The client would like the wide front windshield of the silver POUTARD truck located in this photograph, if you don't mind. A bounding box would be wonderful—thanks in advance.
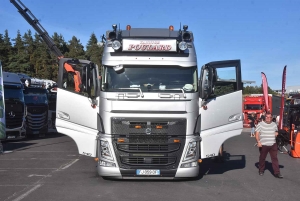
[102,65,198,93]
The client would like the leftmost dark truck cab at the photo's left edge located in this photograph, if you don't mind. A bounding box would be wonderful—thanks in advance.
[3,72,26,140]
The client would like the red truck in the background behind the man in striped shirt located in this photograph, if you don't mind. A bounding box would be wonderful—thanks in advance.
[243,94,281,128]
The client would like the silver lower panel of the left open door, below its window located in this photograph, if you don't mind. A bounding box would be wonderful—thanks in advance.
[56,88,99,157]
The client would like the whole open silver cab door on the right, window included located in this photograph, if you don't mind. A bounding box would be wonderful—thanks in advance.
[199,60,243,159]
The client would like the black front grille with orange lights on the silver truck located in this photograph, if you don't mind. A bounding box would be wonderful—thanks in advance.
[111,118,186,169]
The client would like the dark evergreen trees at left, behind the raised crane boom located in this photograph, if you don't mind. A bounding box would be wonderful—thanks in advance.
[0,30,103,81]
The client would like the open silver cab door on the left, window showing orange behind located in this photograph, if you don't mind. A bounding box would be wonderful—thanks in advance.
[56,58,100,157]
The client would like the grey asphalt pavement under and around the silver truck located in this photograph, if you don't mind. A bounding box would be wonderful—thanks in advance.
[0,129,300,201]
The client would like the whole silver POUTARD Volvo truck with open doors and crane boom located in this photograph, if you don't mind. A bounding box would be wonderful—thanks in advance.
[11,0,243,179]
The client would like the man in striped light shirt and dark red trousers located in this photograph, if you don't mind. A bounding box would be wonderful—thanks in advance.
[255,113,283,178]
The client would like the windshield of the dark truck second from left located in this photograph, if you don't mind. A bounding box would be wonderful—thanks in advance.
[24,88,48,104]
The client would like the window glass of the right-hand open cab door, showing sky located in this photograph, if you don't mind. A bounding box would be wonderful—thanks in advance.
[214,67,237,96]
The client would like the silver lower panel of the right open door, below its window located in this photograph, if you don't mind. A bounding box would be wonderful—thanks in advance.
[200,91,243,158]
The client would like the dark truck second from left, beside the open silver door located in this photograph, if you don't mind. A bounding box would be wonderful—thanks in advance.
[19,74,48,136]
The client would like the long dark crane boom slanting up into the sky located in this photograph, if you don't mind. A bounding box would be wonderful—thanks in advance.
[10,0,64,59]
